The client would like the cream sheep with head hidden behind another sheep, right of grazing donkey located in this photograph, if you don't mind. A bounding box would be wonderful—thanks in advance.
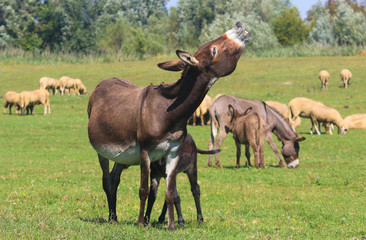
[288,97,324,133]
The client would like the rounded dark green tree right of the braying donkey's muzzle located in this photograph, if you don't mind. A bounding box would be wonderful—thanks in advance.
[273,7,309,45]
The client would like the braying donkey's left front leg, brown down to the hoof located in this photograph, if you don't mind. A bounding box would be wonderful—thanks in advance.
[138,148,150,226]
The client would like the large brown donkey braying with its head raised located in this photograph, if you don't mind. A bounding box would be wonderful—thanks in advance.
[88,22,250,229]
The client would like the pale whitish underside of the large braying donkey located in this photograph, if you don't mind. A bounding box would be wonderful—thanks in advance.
[93,140,179,165]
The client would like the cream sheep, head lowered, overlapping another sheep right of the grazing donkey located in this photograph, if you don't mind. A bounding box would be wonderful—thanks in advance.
[310,106,348,135]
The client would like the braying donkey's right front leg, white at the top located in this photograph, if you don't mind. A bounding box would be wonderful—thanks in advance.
[165,151,179,230]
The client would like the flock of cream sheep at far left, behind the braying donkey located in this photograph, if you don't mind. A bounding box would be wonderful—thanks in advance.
[4,76,87,115]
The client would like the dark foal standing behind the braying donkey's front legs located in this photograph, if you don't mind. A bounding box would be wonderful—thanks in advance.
[145,134,220,227]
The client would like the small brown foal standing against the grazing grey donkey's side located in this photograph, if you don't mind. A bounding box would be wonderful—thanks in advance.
[229,105,265,168]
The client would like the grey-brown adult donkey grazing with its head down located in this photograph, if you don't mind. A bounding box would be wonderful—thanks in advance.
[208,95,305,168]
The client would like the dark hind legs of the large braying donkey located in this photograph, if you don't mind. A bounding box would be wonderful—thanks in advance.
[98,154,127,222]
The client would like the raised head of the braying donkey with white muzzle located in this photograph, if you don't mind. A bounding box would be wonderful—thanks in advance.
[158,22,250,78]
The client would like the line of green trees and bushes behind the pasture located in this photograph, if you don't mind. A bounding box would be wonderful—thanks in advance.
[0,0,366,60]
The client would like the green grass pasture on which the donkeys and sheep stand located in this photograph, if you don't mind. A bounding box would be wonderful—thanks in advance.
[0,54,366,239]
